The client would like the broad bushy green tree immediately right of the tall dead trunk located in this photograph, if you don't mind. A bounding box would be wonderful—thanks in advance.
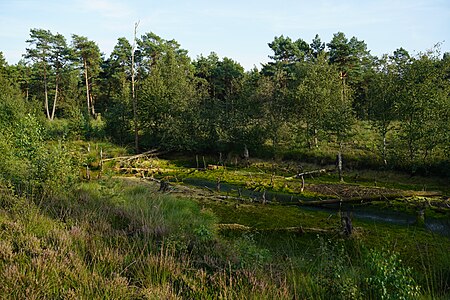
[138,34,197,150]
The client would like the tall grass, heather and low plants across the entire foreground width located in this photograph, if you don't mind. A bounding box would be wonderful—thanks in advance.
[0,179,449,299]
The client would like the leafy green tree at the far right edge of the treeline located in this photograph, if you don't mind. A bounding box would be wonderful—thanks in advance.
[398,49,449,172]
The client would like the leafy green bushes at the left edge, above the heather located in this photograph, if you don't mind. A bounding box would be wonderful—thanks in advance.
[0,76,76,196]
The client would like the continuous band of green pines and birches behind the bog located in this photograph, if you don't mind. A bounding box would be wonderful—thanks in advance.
[0,29,450,170]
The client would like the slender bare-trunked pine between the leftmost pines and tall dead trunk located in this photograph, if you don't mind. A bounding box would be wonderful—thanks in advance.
[72,34,102,117]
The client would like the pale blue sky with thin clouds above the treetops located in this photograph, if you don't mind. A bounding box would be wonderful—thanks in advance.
[0,0,450,70]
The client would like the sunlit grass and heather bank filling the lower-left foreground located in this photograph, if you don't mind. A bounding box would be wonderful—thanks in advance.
[0,179,300,299]
